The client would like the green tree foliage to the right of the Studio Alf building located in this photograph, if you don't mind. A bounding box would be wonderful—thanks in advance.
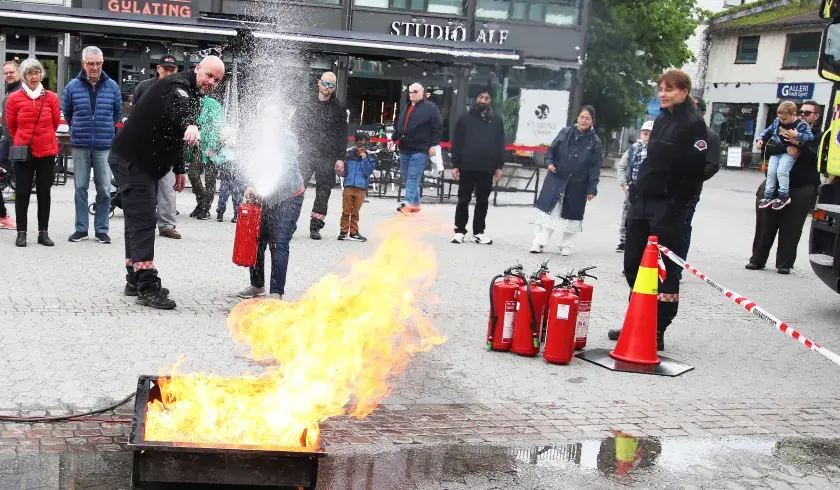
[583,0,705,138]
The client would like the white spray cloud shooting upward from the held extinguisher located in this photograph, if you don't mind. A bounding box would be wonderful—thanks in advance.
[225,0,315,196]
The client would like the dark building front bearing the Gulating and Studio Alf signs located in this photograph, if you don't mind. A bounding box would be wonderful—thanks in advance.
[0,0,589,145]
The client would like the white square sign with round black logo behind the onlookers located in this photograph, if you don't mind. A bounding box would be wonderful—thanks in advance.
[516,89,569,146]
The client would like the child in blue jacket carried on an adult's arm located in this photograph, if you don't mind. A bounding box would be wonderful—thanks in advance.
[756,101,814,211]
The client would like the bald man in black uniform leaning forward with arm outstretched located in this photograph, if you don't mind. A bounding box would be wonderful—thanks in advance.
[108,56,225,310]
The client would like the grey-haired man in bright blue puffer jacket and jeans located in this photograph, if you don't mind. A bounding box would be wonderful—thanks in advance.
[61,46,122,243]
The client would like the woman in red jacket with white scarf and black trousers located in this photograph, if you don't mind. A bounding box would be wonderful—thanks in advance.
[5,58,61,247]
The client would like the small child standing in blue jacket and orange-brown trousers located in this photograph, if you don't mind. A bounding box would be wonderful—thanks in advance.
[338,132,376,242]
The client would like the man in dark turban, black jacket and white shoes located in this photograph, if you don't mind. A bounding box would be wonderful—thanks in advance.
[451,87,505,245]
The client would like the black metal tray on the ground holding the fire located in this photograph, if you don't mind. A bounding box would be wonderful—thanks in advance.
[128,376,327,490]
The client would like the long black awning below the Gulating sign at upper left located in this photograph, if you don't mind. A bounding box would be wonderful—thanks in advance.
[0,2,236,41]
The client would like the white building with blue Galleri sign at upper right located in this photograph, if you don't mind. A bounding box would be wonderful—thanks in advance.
[704,2,831,164]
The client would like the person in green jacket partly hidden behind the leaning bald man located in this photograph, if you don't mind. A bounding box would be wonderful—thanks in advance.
[187,95,224,220]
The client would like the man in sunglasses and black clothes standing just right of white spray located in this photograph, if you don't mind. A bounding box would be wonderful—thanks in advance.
[299,71,347,240]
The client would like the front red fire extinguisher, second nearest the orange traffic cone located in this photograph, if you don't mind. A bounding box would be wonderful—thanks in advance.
[543,276,580,364]
